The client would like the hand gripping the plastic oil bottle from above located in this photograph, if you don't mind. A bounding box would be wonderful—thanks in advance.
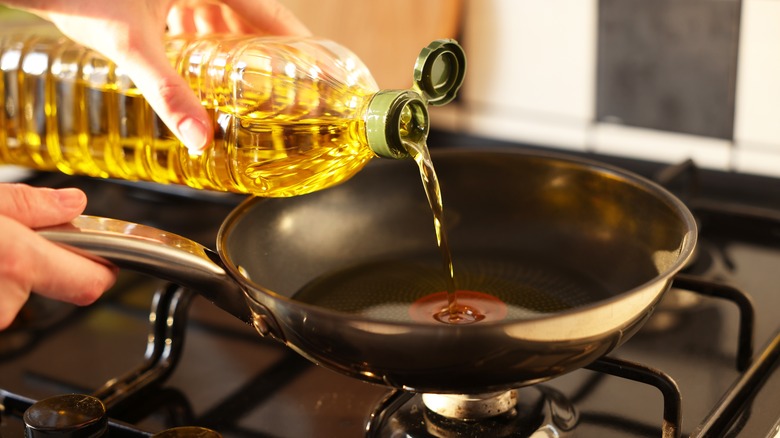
[0,0,309,151]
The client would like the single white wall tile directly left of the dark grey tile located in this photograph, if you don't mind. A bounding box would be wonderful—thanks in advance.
[462,0,596,128]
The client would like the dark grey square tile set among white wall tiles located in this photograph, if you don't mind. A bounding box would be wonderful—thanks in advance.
[596,0,740,139]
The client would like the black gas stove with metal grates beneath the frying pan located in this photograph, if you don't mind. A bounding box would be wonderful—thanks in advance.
[0,133,780,438]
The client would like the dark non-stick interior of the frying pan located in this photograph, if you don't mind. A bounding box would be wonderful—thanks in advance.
[224,151,691,322]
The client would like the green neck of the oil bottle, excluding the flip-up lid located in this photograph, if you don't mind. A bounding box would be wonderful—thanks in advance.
[365,90,430,159]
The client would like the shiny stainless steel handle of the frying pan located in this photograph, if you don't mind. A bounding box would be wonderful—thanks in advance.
[38,216,252,324]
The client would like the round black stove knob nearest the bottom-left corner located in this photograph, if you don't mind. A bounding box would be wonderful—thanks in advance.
[24,394,108,438]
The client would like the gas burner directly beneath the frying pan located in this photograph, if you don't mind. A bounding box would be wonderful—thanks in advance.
[368,385,579,438]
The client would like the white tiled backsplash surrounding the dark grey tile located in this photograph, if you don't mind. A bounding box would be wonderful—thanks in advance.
[444,0,780,177]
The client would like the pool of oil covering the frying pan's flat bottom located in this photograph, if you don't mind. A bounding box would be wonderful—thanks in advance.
[294,253,611,324]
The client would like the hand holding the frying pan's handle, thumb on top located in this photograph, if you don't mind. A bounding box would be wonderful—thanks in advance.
[0,184,116,330]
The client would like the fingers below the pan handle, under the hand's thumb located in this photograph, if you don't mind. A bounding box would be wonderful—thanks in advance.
[0,216,116,330]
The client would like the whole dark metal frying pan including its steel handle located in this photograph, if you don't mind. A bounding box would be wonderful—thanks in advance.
[41,149,696,394]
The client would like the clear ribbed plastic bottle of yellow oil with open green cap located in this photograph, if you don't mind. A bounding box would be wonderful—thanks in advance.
[0,34,465,197]
